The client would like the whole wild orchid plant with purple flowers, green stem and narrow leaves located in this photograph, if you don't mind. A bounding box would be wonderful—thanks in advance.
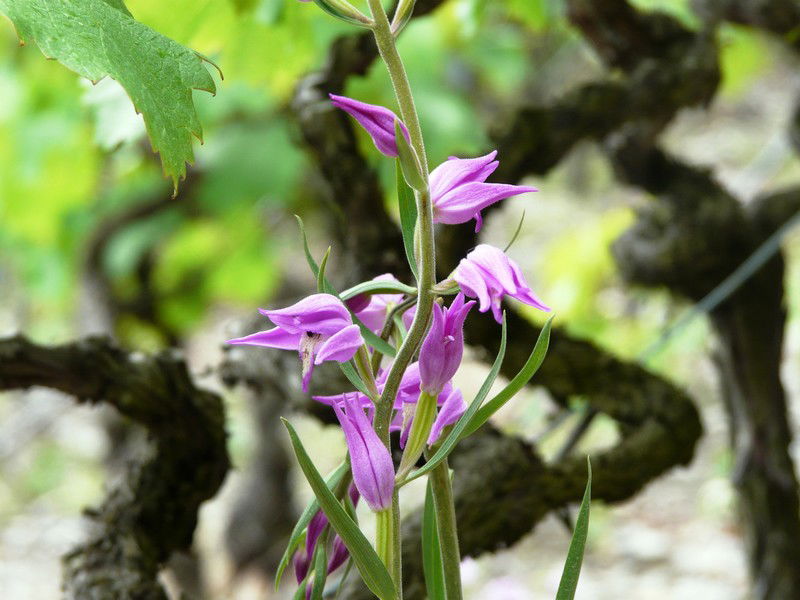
[230,0,589,600]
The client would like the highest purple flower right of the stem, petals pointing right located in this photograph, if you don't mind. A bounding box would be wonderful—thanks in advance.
[430,150,538,232]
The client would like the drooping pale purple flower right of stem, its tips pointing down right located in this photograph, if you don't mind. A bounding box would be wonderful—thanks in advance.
[453,244,550,323]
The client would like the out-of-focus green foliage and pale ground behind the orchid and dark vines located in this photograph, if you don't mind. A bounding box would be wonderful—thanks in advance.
[0,0,800,600]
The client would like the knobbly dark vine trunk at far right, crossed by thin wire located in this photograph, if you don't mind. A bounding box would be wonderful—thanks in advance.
[612,134,800,599]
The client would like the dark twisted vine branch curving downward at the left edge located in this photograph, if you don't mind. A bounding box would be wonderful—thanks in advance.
[0,337,229,600]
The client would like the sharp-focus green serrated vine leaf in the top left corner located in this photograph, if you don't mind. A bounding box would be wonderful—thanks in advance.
[0,0,216,190]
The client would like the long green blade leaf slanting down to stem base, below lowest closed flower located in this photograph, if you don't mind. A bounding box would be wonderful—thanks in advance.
[281,418,396,600]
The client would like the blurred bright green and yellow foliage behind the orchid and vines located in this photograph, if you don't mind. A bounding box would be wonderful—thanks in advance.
[0,0,792,356]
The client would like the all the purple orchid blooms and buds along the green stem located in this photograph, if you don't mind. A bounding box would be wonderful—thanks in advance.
[230,95,549,582]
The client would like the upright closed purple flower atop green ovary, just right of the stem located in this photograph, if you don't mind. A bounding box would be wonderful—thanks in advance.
[419,293,475,396]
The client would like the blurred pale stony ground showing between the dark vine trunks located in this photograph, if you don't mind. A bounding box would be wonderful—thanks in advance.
[0,27,800,600]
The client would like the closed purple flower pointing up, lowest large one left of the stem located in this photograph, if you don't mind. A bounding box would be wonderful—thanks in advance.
[333,394,394,512]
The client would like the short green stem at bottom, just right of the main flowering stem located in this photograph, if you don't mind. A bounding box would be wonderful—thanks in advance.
[429,459,462,600]
